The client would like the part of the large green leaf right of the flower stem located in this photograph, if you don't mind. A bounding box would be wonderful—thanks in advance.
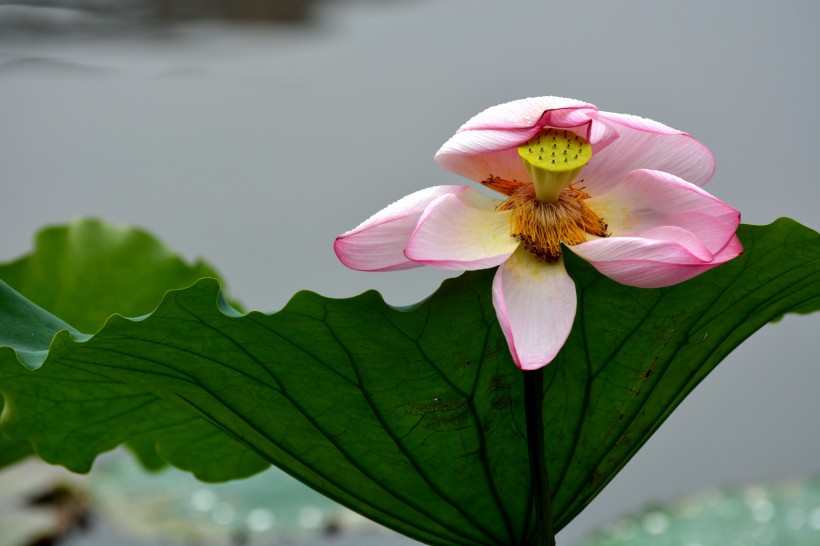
[544,218,820,528]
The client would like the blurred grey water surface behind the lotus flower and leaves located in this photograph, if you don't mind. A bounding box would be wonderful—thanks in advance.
[0,0,820,546]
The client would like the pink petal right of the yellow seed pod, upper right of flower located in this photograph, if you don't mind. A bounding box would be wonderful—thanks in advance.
[580,112,715,195]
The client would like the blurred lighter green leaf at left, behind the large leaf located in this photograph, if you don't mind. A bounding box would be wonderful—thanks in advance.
[0,219,231,468]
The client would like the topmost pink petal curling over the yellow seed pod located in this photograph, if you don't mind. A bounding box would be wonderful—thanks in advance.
[435,97,596,182]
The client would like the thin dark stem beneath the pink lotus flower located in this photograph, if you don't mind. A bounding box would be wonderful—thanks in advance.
[524,368,555,546]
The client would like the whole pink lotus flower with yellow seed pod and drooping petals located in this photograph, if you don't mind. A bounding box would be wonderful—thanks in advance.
[334,97,743,370]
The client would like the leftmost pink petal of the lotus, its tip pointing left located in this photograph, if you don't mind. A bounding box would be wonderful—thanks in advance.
[333,186,474,271]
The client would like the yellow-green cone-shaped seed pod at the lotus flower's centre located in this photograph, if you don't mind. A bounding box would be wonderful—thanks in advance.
[518,129,592,203]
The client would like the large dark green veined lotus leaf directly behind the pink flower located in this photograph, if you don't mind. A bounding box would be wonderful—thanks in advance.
[0,220,820,545]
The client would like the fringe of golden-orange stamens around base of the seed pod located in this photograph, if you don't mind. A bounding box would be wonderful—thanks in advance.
[498,184,607,263]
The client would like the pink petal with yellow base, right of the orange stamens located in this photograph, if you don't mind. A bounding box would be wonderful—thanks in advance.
[587,169,740,253]
